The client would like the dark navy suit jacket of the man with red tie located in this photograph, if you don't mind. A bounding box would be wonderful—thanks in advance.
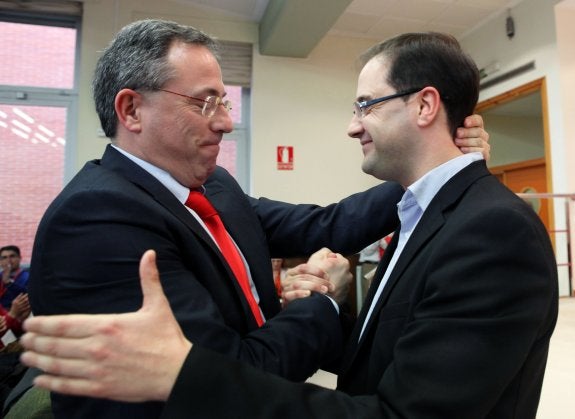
[30,147,401,419]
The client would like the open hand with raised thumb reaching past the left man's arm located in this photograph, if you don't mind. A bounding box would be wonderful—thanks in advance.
[21,250,192,402]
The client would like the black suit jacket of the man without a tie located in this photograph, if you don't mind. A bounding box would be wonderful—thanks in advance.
[169,161,558,419]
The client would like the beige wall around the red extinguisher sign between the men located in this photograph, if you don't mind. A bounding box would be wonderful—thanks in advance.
[252,37,376,203]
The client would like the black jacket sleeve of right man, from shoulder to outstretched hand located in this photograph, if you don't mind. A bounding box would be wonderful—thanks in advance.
[163,198,557,419]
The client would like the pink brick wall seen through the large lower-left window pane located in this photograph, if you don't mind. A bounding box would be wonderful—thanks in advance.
[0,105,65,262]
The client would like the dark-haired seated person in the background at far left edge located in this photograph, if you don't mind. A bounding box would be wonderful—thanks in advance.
[0,245,29,310]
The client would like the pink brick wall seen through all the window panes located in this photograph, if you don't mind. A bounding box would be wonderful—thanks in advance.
[0,22,242,263]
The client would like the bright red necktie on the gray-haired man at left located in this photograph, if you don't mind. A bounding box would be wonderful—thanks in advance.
[186,191,264,326]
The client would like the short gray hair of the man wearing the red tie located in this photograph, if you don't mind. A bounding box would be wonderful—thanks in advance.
[92,19,219,138]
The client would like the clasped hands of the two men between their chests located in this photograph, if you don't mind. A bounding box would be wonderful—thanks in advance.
[281,247,352,307]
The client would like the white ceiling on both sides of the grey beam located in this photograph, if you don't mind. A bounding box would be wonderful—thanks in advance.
[175,0,522,40]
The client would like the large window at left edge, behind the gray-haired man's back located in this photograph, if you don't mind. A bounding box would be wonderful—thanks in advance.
[0,13,78,263]
